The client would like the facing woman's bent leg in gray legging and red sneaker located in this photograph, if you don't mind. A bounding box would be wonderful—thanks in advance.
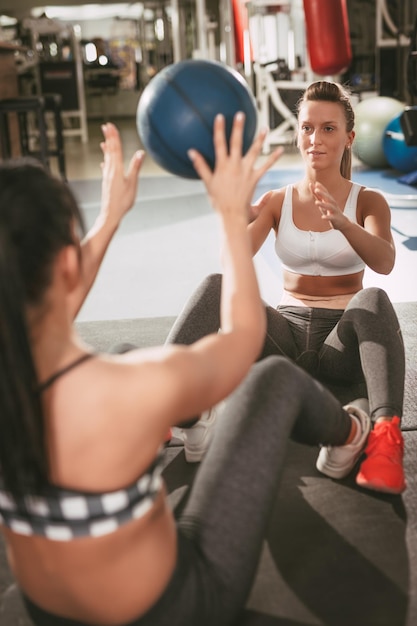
[321,288,406,493]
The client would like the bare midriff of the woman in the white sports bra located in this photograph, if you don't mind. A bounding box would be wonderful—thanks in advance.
[280,270,363,309]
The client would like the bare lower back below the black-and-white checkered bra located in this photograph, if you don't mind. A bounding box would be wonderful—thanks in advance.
[4,493,177,626]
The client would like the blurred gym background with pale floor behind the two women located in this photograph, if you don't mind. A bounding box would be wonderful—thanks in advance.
[0,0,417,320]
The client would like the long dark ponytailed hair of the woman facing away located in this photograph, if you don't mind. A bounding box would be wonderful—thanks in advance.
[0,159,84,494]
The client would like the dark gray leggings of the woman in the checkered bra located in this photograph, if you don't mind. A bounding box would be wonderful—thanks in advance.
[25,356,351,626]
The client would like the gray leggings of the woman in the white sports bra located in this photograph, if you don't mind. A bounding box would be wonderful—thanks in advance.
[167,274,405,419]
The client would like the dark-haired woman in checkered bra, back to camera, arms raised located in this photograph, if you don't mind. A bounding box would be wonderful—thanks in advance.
[0,114,367,626]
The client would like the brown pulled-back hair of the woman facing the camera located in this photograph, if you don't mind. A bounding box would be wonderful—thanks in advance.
[297,80,355,179]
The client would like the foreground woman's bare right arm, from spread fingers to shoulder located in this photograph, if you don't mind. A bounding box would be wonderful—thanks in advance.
[101,114,280,448]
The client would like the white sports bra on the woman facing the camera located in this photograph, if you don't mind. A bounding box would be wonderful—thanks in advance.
[275,183,365,276]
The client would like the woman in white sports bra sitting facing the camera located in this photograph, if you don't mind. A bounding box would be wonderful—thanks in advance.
[168,81,406,493]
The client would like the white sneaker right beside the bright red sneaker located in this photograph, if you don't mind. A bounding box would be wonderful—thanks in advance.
[316,398,371,478]
